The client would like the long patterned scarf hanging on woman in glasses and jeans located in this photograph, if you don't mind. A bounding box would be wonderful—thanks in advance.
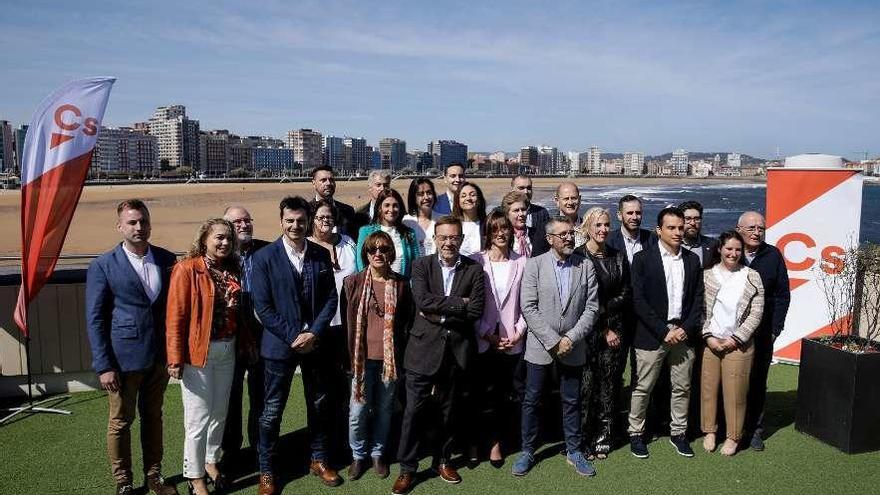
[352,274,397,404]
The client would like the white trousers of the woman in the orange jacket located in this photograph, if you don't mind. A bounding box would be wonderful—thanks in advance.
[180,339,235,478]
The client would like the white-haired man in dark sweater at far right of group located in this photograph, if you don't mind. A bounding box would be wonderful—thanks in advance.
[736,211,791,451]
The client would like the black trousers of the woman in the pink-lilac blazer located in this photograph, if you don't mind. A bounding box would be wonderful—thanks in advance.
[474,350,523,450]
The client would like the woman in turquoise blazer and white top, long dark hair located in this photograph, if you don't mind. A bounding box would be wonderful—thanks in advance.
[355,189,420,277]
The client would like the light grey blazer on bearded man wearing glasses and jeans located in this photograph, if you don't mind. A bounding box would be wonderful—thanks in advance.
[520,250,599,366]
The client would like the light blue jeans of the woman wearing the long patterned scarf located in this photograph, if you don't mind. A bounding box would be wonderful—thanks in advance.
[348,359,396,459]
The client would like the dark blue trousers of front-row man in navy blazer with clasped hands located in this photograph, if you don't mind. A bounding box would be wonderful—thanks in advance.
[259,351,332,473]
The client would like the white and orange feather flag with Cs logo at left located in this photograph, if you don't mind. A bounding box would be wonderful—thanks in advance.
[15,77,116,337]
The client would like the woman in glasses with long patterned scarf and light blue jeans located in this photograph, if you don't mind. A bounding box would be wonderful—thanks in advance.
[339,232,414,480]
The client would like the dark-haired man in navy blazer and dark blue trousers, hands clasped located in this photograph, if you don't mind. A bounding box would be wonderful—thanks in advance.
[251,196,342,495]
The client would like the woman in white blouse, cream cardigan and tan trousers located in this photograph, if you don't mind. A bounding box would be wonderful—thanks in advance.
[700,230,764,456]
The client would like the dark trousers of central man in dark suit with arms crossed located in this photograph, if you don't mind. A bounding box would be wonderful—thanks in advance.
[397,349,465,473]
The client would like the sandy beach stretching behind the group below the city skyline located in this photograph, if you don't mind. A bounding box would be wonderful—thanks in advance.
[0,177,760,260]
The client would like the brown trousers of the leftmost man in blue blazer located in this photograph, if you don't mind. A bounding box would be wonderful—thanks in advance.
[107,364,168,483]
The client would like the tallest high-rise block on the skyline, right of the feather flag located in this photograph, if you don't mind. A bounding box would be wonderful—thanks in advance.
[149,105,201,168]
